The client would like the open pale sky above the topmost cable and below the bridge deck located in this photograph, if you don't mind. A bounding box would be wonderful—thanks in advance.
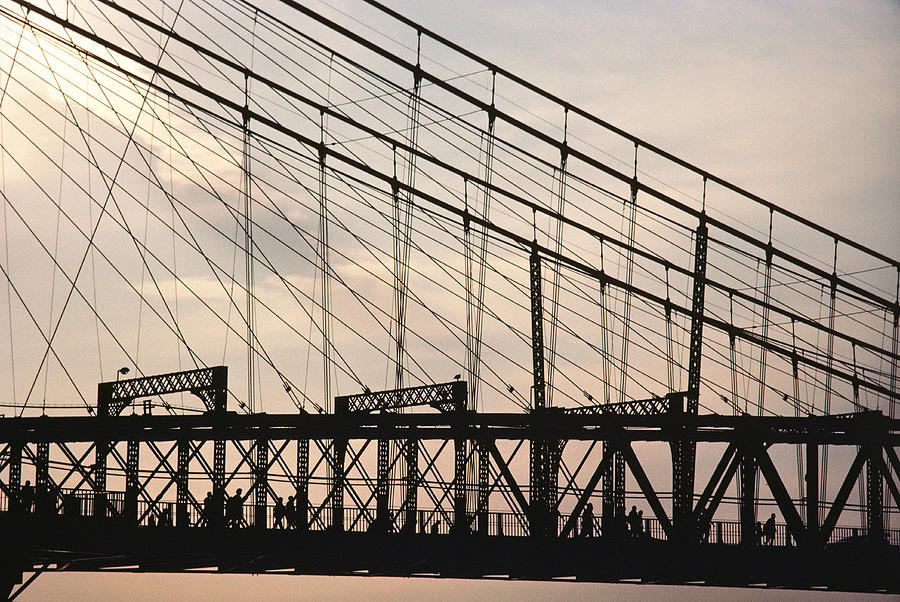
[12,0,900,600]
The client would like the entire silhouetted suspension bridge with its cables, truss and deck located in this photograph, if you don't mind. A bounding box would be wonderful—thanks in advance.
[0,0,900,597]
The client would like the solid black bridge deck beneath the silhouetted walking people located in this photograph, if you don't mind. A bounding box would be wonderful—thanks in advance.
[0,513,900,593]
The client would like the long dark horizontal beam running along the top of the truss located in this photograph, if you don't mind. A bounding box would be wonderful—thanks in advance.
[0,412,900,447]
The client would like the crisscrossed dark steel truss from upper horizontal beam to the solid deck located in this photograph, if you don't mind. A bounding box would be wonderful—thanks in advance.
[0,400,900,587]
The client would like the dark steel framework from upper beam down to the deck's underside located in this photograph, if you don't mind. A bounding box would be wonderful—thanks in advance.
[0,400,900,591]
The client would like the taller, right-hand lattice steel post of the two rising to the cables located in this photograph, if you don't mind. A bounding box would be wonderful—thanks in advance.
[672,212,709,538]
